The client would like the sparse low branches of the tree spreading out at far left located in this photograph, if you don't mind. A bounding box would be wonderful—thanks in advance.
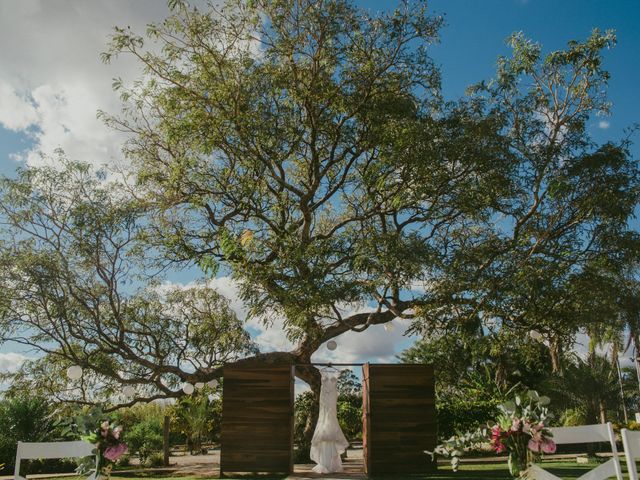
[0,156,257,403]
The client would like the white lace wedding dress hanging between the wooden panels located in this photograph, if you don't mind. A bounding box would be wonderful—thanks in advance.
[311,371,349,473]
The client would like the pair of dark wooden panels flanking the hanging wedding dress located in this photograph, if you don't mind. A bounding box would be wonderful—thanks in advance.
[220,363,437,478]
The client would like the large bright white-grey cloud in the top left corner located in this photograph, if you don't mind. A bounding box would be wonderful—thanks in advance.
[0,0,174,169]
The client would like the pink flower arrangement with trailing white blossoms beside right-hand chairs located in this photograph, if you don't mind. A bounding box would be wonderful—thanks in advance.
[425,390,556,477]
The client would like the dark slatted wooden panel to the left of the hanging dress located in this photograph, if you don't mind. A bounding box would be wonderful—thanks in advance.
[220,365,294,477]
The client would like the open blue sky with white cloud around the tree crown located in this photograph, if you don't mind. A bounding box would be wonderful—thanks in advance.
[0,0,640,368]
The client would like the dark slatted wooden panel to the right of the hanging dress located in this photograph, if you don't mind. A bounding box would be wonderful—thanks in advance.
[362,364,437,476]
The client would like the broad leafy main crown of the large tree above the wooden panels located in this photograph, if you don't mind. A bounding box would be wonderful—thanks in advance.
[1,0,638,450]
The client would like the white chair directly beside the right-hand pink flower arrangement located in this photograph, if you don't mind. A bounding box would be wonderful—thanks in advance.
[527,423,622,480]
